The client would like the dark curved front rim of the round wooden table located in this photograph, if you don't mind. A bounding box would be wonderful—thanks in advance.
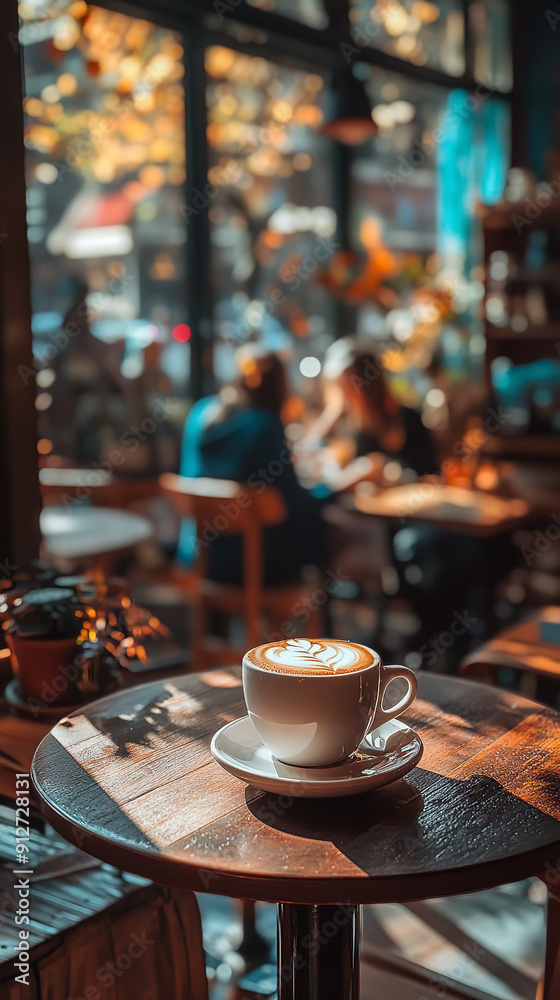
[31,760,560,905]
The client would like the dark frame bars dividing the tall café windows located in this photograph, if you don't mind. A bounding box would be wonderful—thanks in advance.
[95,0,520,400]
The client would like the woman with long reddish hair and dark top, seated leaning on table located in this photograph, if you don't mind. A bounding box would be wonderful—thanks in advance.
[304,338,511,658]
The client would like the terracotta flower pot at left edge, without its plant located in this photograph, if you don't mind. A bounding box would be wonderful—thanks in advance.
[6,632,78,707]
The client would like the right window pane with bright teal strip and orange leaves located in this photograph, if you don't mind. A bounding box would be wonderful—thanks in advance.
[345,67,509,405]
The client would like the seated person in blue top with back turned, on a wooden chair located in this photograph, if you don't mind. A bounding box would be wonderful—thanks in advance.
[177,345,325,586]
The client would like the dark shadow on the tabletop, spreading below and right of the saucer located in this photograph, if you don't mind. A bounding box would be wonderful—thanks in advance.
[247,767,560,877]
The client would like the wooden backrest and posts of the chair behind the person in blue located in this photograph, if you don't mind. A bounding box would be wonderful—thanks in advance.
[159,472,287,605]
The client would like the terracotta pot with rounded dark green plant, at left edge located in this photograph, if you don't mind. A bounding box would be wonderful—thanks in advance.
[6,587,82,707]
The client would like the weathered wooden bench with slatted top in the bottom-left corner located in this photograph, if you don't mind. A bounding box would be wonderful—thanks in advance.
[0,808,208,1000]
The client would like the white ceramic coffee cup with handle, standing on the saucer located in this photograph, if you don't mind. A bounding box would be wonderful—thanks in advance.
[243,639,418,767]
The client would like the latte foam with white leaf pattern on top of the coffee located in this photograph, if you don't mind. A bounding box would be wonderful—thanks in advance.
[247,639,376,674]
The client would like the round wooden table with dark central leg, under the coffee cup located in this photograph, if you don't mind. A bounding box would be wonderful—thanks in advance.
[32,668,560,1000]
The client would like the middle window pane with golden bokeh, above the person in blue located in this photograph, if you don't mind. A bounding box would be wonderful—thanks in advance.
[206,46,337,390]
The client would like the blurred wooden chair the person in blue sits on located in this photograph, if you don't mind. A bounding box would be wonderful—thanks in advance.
[160,473,321,670]
